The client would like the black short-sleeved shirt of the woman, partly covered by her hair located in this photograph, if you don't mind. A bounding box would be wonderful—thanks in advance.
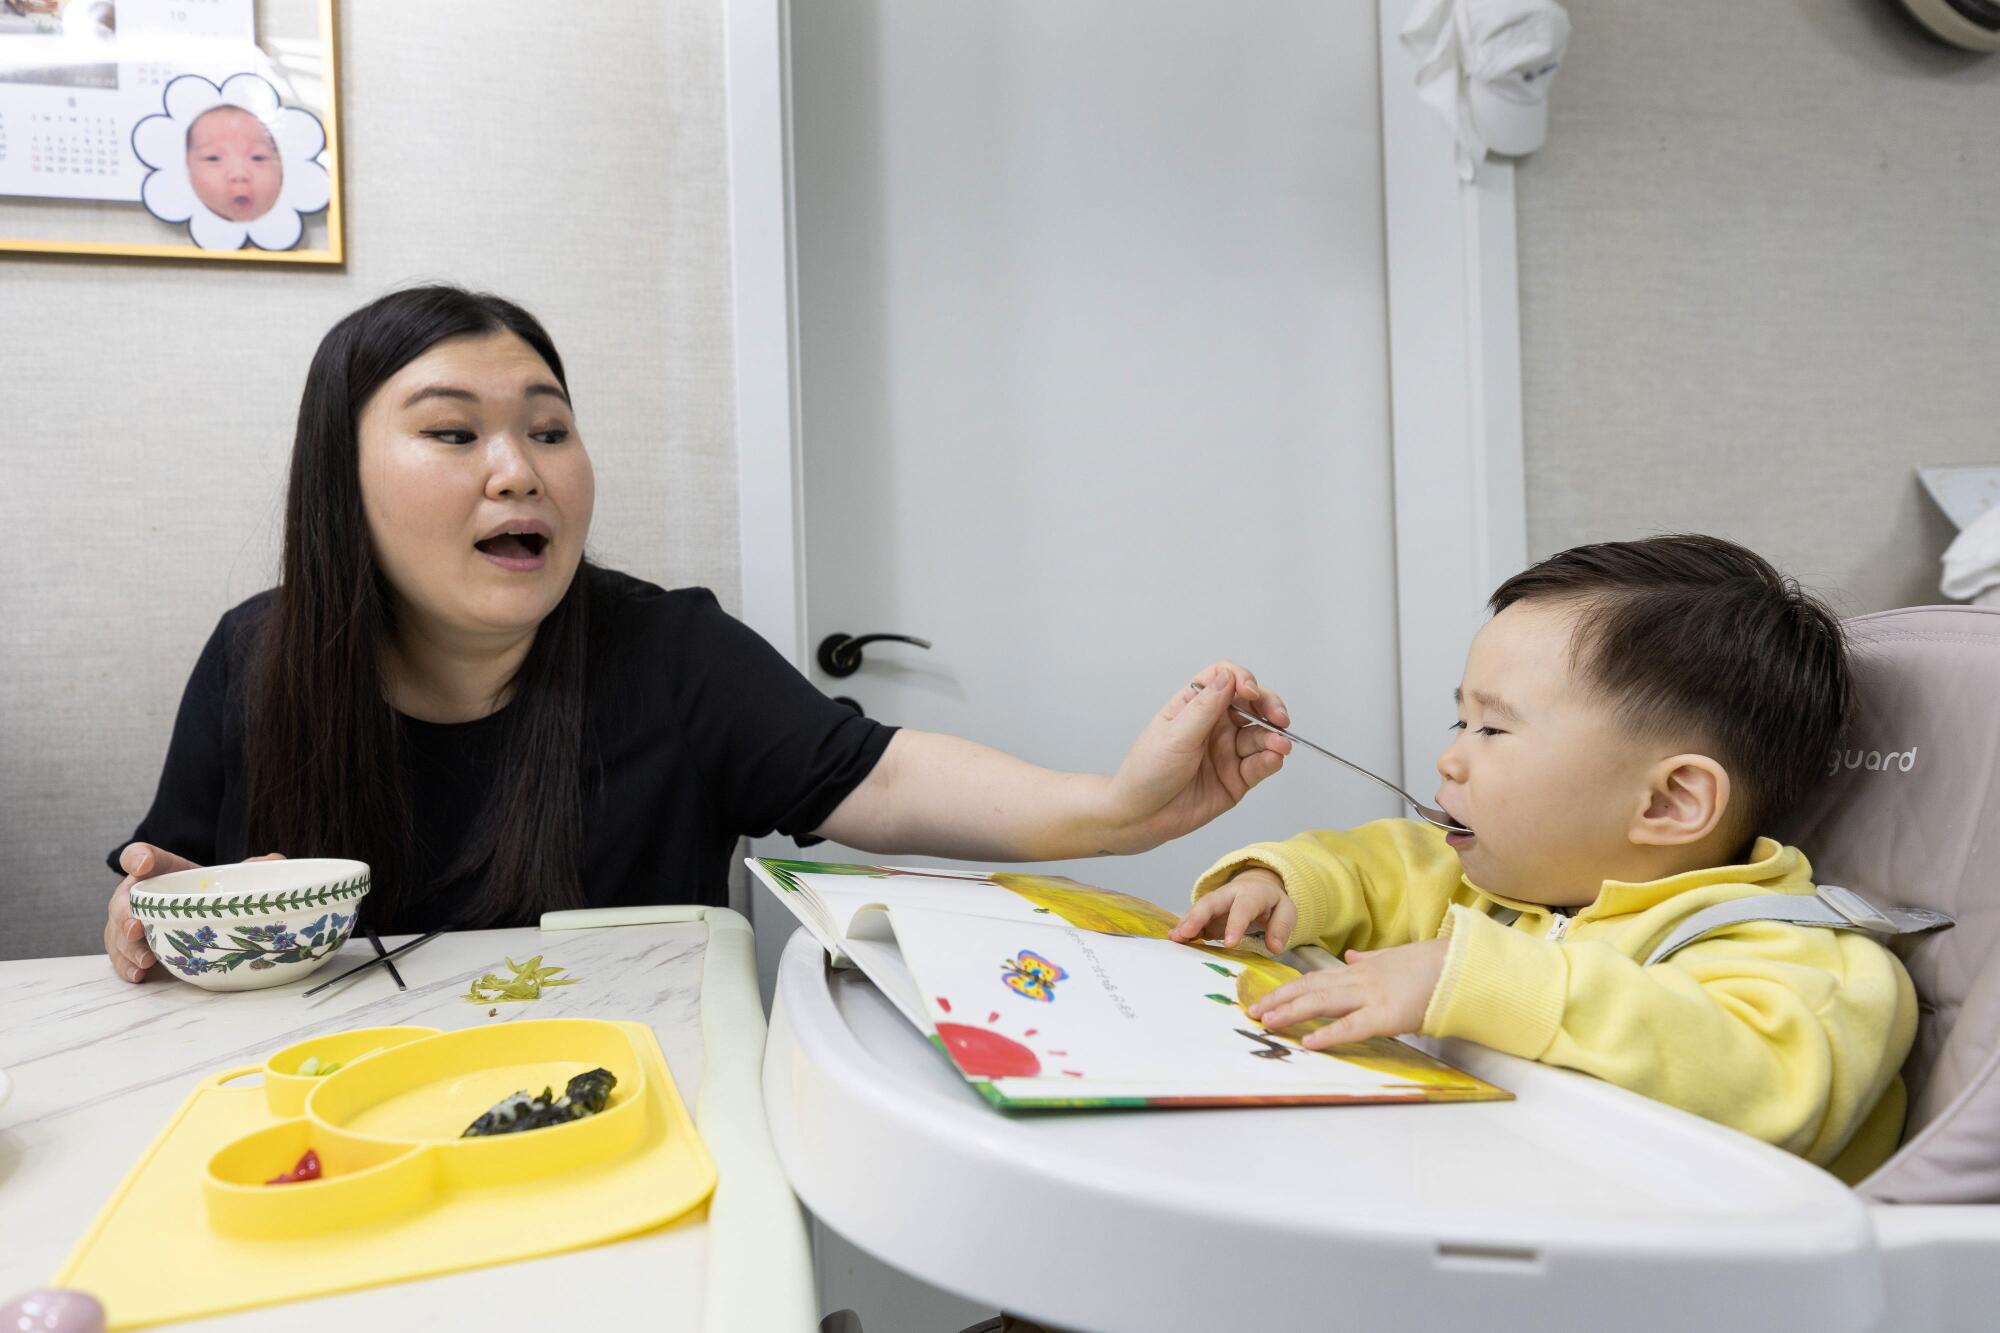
[108,564,896,935]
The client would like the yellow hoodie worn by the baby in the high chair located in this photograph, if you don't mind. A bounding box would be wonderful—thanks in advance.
[1194,819,1916,1183]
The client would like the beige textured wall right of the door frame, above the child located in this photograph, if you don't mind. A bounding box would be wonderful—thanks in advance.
[1518,0,2000,612]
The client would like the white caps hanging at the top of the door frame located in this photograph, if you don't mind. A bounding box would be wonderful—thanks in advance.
[1402,0,1570,180]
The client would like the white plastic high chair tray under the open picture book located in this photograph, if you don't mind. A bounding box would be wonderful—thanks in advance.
[764,933,1882,1333]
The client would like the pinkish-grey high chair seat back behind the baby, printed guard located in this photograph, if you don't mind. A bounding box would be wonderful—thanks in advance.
[1780,606,2000,1203]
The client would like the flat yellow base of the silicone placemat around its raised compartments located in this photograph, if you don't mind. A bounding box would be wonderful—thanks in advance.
[54,1023,716,1329]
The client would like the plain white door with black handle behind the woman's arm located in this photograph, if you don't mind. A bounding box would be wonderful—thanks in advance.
[766,0,1400,896]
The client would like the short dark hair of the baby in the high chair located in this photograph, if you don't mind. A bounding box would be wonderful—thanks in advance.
[1488,534,1852,837]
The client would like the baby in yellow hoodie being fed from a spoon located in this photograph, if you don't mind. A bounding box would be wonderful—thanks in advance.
[1174,536,1916,1181]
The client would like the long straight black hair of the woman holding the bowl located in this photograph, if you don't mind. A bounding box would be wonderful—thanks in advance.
[244,286,590,927]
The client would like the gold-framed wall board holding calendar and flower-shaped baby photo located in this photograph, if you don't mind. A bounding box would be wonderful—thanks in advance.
[0,0,344,264]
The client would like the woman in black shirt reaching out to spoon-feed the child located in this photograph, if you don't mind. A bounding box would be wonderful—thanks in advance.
[104,286,1290,981]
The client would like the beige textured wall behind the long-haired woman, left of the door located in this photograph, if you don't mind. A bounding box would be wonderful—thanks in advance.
[0,0,738,959]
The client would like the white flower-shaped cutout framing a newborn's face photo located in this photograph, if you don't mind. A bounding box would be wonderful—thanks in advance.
[132,74,332,250]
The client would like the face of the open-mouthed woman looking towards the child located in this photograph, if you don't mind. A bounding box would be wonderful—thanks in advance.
[358,332,596,636]
